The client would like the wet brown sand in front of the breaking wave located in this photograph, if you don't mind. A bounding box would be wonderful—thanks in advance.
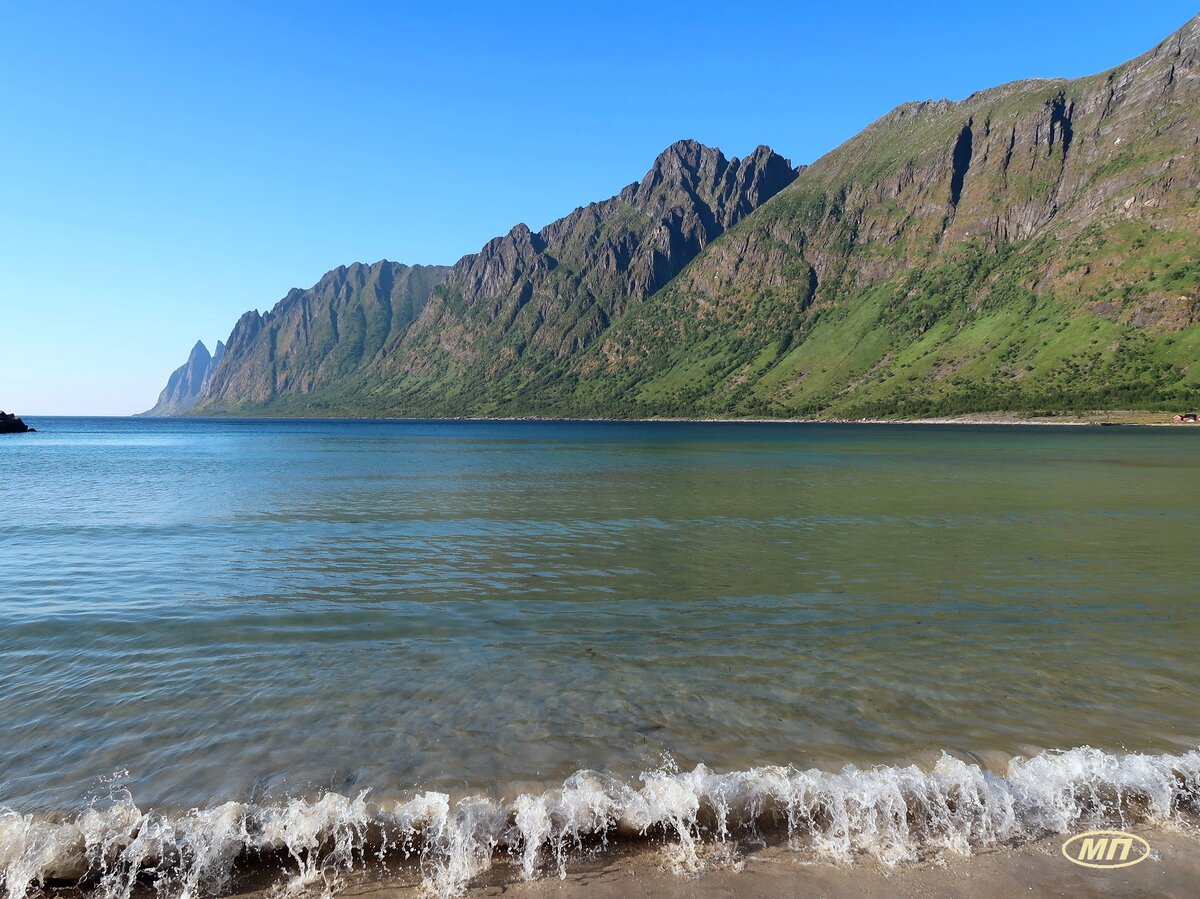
[341,828,1200,899]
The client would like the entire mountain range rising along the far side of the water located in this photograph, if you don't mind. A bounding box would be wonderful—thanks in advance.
[150,17,1200,418]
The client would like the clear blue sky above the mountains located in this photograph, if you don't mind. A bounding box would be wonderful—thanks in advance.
[0,0,1196,414]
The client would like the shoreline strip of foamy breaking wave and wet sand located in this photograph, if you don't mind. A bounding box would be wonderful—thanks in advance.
[11,748,1200,899]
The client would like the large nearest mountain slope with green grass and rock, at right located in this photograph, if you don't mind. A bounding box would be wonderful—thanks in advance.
[568,19,1200,416]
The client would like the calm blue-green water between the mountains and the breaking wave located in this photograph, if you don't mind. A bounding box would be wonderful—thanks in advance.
[0,419,1200,811]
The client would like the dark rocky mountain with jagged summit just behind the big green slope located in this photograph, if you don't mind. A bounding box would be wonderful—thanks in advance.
[376,139,796,374]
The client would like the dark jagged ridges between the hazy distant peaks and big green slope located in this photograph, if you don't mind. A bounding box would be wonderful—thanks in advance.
[189,140,796,412]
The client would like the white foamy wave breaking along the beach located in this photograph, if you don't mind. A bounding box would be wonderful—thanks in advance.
[0,747,1200,899]
